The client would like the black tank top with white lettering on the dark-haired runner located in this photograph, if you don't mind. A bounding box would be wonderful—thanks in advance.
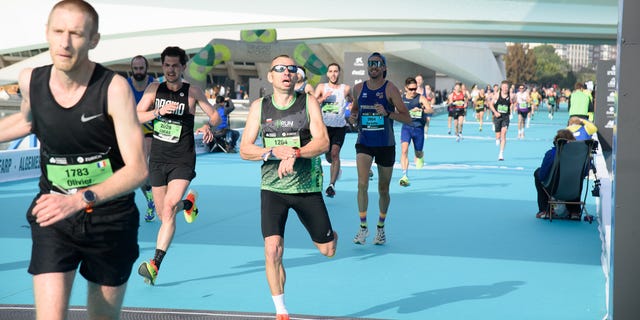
[149,82,196,166]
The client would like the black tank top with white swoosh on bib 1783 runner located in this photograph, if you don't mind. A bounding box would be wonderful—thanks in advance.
[29,64,128,195]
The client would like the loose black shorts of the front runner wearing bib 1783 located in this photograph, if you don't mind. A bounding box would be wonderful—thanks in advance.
[27,193,140,287]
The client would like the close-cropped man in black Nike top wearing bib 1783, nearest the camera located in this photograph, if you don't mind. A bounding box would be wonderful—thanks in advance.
[0,1,147,319]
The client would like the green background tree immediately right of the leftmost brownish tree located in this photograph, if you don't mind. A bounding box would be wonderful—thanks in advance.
[533,45,571,84]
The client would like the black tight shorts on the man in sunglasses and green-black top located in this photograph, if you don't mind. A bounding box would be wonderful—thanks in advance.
[260,190,333,243]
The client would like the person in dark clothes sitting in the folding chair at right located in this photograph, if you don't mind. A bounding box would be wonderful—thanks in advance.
[533,129,580,220]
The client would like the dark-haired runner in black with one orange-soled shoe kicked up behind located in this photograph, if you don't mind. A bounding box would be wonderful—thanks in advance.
[132,47,220,285]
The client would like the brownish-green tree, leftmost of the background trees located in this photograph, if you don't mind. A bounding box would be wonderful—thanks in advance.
[504,43,536,83]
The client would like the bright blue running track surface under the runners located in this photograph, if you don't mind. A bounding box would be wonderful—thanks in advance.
[0,111,606,320]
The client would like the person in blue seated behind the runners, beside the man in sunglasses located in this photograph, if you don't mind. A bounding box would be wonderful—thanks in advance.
[196,96,240,153]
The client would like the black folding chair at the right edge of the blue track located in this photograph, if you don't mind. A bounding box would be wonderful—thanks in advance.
[542,139,596,223]
